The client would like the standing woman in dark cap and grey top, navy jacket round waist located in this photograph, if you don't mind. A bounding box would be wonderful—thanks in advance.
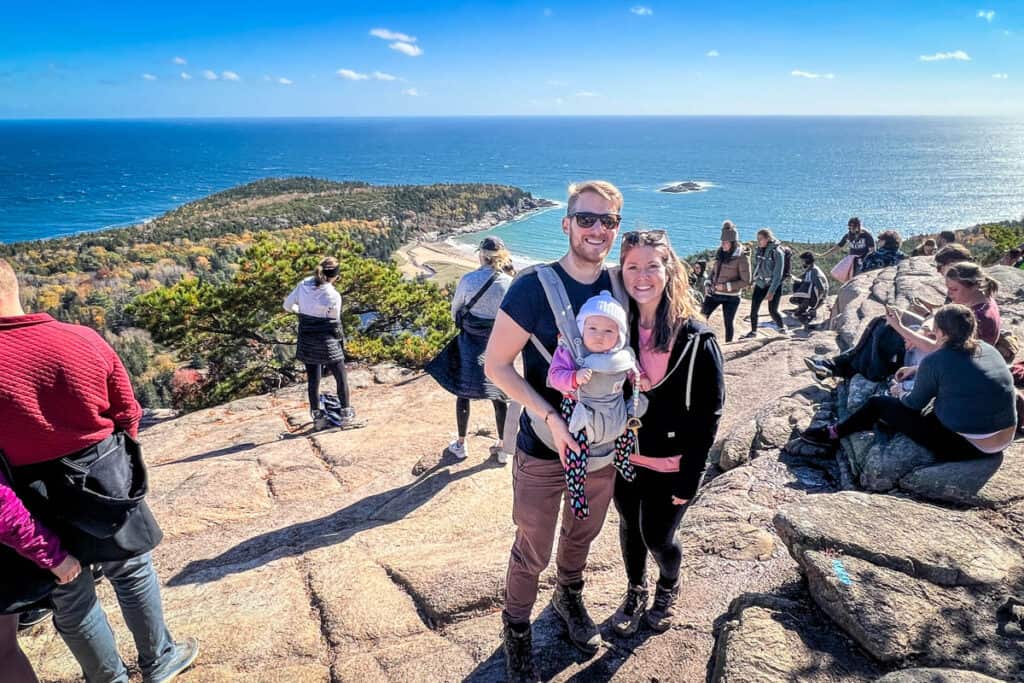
[426,236,514,465]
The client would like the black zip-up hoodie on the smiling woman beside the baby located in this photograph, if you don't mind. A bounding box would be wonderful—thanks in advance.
[630,315,725,500]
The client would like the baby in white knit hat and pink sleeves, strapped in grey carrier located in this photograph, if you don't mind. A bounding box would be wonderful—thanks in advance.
[548,292,650,519]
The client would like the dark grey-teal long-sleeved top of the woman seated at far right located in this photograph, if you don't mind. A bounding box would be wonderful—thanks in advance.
[903,342,1017,434]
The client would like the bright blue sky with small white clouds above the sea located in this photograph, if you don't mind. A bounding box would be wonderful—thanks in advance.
[0,0,1024,119]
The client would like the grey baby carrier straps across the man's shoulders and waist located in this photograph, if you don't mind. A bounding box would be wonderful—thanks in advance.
[504,263,630,457]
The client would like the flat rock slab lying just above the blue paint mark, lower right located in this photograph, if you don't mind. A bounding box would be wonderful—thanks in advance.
[775,492,1024,587]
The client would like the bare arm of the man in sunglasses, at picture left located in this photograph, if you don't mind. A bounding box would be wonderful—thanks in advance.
[483,310,580,466]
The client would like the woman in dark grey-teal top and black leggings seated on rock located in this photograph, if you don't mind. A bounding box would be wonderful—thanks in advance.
[802,304,1017,460]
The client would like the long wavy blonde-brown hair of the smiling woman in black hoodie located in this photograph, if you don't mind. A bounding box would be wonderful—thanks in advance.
[618,230,702,352]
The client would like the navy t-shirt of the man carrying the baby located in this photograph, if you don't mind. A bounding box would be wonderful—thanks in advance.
[502,263,611,460]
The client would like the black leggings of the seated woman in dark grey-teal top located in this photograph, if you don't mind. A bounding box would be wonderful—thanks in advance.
[836,396,988,460]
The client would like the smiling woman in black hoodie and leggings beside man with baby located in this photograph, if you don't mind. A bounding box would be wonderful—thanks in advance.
[611,230,725,636]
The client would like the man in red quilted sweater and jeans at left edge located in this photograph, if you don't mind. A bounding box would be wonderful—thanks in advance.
[0,259,199,683]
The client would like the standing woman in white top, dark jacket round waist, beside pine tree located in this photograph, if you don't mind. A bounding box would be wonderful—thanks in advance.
[285,256,364,430]
